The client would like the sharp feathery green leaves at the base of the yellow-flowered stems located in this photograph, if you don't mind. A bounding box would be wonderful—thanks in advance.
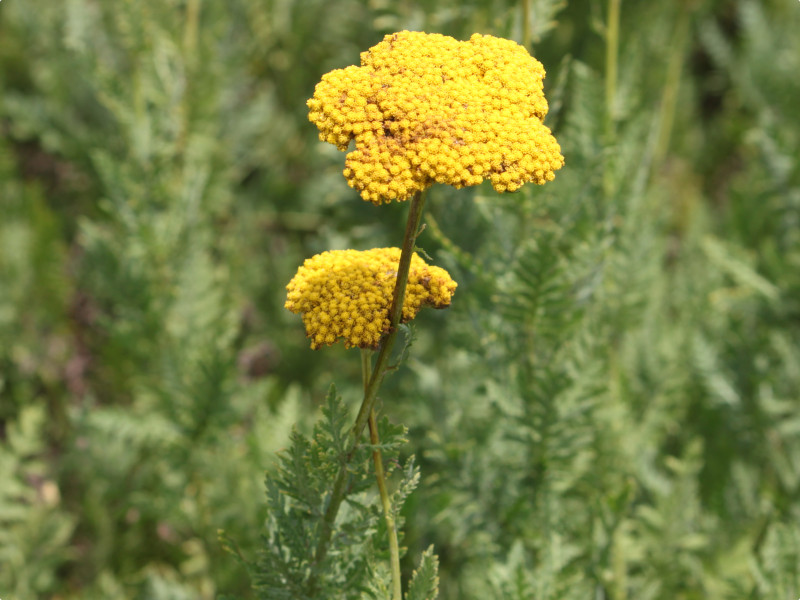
[222,386,428,599]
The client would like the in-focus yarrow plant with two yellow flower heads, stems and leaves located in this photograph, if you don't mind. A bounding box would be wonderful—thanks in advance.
[228,31,564,600]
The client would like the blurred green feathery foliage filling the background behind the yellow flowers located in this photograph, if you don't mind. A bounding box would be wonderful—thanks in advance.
[0,0,800,600]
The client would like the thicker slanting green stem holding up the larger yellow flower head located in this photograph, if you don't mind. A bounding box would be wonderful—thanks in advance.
[309,192,425,580]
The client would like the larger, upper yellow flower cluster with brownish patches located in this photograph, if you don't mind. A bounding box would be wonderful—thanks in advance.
[308,31,564,204]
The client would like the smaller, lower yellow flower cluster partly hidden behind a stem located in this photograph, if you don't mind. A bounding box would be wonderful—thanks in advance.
[286,248,457,349]
